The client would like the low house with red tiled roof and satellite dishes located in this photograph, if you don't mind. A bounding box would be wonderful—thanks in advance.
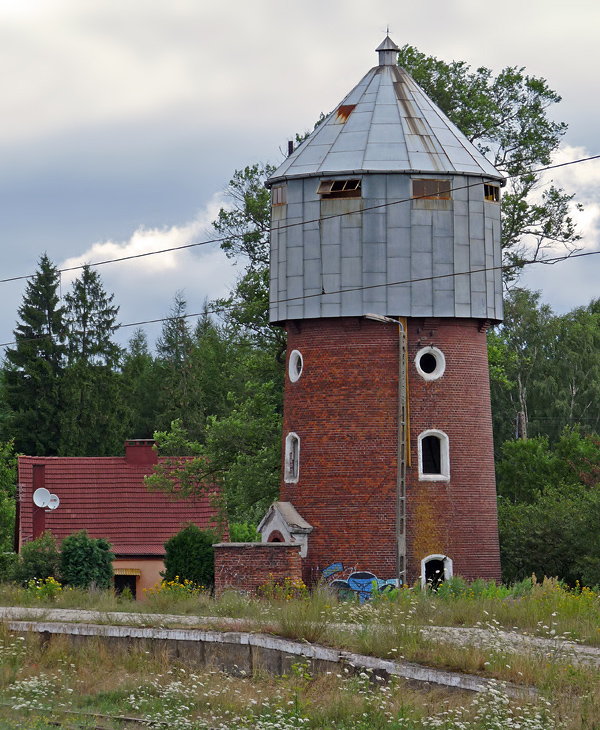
[17,440,221,598]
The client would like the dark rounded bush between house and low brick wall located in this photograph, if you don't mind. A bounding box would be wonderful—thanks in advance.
[163,523,217,589]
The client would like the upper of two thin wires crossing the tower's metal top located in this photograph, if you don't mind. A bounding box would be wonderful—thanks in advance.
[0,155,600,288]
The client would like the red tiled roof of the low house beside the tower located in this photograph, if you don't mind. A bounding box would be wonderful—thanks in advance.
[19,446,225,556]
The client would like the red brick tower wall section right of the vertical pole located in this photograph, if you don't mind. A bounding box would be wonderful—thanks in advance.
[406,319,500,580]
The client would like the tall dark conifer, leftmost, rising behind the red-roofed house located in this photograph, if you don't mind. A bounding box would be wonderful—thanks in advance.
[3,254,65,456]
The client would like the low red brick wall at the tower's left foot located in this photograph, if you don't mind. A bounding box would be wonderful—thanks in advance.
[215,542,302,594]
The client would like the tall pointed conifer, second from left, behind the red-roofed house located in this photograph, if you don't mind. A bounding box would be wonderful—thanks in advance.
[60,265,126,456]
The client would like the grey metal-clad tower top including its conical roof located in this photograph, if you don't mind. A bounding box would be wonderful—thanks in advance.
[267,36,503,323]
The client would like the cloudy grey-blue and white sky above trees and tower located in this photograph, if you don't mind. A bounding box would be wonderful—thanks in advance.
[0,0,600,344]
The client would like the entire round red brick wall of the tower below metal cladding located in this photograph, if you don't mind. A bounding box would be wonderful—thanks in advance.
[281,318,500,581]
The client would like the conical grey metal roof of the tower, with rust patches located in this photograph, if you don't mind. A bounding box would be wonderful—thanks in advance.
[268,36,502,185]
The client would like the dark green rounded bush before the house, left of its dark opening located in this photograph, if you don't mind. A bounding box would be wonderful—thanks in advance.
[60,530,114,590]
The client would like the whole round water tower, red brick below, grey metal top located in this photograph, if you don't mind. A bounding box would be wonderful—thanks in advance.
[263,37,502,583]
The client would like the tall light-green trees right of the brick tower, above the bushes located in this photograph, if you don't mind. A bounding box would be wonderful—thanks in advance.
[488,288,600,451]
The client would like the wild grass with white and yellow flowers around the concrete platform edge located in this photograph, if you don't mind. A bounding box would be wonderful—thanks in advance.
[0,580,600,730]
